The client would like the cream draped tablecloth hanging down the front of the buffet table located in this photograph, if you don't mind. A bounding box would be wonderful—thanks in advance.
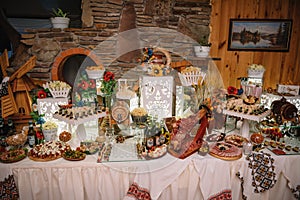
[0,146,300,200]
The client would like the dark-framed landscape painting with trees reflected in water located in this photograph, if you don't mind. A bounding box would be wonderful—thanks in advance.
[228,19,292,51]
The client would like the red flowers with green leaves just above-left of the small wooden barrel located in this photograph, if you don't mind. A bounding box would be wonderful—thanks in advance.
[100,71,117,96]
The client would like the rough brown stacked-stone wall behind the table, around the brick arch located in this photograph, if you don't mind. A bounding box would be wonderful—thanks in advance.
[22,0,211,80]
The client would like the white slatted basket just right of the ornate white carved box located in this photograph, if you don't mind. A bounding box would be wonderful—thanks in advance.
[178,71,206,86]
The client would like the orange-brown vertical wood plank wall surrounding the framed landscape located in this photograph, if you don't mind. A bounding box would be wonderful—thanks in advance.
[211,0,300,88]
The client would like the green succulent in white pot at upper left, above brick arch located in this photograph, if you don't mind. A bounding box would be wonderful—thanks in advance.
[50,8,70,29]
